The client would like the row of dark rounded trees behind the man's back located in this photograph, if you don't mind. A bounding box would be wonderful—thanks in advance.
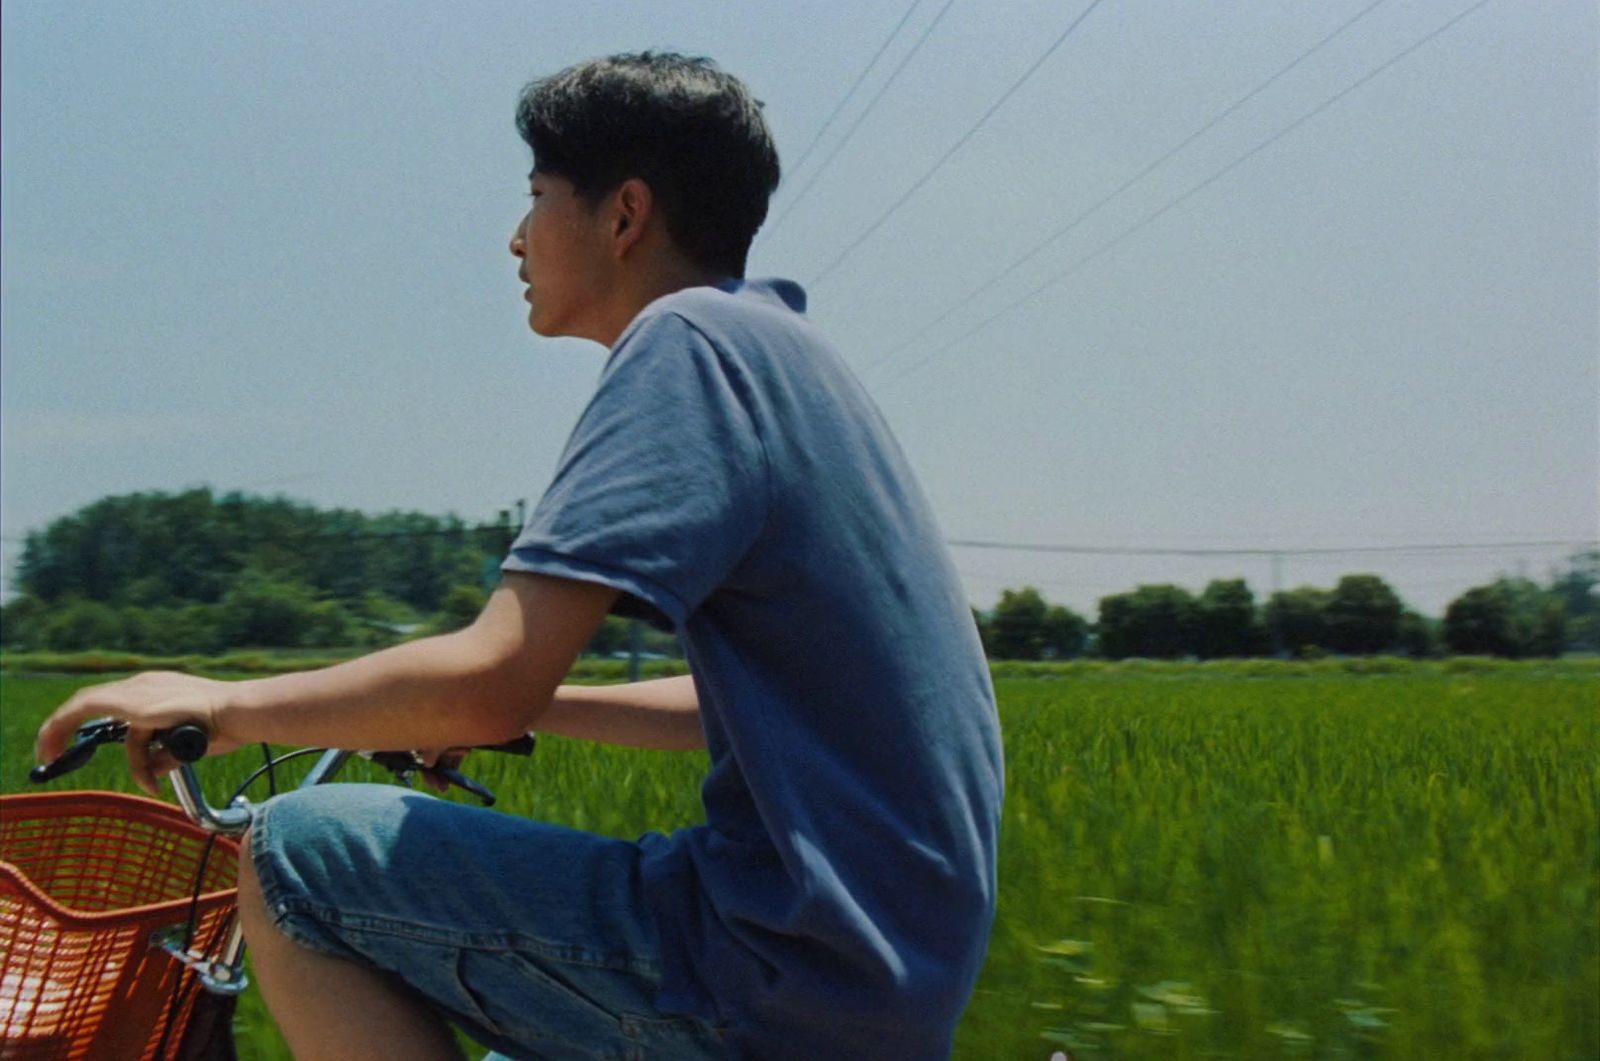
[973,549,1600,659]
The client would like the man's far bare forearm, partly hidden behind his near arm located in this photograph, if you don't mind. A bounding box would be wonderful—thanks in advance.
[534,674,706,751]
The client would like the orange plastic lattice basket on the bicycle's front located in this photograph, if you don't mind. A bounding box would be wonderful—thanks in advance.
[0,792,238,1061]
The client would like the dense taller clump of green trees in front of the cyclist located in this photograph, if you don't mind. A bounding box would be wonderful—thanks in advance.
[0,488,675,655]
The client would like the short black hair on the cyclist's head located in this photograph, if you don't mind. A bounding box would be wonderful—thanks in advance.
[517,51,779,277]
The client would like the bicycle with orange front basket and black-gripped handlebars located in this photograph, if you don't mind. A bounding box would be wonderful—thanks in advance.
[0,719,534,1061]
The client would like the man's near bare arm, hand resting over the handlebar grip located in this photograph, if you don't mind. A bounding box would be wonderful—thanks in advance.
[35,573,618,792]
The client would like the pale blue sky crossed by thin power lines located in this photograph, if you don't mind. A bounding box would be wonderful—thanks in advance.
[0,0,1600,615]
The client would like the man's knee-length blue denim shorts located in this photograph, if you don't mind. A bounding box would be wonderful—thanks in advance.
[251,784,725,1059]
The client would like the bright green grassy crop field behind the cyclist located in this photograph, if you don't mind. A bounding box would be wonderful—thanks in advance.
[0,661,1600,1061]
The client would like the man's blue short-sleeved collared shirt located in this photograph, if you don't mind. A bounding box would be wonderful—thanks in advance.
[504,280,1003,1059]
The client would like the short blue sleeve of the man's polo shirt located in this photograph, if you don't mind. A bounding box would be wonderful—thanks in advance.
[501,314,768,626]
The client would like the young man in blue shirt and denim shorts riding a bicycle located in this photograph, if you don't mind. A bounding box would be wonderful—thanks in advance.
[37,53,1003,1059]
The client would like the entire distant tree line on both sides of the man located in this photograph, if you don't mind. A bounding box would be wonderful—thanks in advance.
[0,488,1600,659]
